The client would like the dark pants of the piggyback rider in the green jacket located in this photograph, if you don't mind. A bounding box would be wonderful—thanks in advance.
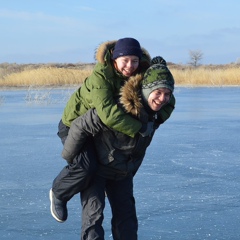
[52,121,97,201]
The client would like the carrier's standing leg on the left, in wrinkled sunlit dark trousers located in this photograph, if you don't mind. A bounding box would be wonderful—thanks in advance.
[81,176,106,240]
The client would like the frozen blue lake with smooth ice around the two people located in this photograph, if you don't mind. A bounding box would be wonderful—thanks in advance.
[0,87,240,240]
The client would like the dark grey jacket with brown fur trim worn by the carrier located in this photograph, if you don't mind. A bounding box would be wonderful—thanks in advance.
[62,75,175,180]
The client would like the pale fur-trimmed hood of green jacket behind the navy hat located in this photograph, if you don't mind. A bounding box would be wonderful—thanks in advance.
[95,40,151,63]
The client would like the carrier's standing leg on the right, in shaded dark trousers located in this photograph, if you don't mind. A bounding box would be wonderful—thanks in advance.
[106,177,138,240]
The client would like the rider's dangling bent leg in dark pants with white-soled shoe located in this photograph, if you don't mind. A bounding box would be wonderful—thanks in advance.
[49,136,97,222]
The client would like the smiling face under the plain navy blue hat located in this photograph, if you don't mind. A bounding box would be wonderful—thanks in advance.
[115,55,139,77]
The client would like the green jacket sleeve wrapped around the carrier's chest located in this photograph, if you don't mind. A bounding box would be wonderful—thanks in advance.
[91,72,142,137]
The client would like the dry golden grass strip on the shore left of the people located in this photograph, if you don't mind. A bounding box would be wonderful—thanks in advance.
[0,64,92,87]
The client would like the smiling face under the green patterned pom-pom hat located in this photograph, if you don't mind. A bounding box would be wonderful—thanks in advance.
[148,88,172,112]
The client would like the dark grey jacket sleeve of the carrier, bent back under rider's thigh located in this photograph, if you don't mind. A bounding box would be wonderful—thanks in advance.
[62,109,107,163]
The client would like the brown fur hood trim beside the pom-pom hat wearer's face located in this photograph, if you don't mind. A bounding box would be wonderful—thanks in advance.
[120,74,143,118]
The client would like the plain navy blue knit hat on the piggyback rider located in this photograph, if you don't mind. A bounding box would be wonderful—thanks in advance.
[112,38,142,59]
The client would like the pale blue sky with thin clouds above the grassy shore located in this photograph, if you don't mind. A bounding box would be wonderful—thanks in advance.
[0,0,240,64]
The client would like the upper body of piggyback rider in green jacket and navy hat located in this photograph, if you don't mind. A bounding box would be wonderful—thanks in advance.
[58,38,151,142]
